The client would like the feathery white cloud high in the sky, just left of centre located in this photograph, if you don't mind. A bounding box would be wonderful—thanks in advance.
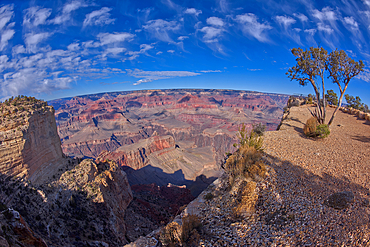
[143,19,181,43]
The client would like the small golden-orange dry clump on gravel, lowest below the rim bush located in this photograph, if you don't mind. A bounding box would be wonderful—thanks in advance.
[233,181,258,217]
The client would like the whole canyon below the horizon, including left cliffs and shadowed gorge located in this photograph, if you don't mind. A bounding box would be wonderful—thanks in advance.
[0,89,288,246]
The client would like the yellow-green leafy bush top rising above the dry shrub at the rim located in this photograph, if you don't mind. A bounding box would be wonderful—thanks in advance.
[234,123,263,151]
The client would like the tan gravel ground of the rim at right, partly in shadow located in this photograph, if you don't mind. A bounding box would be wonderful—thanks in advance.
[198,107,370,246]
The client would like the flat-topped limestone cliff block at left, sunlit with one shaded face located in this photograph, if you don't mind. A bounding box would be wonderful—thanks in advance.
[0,97,64,182]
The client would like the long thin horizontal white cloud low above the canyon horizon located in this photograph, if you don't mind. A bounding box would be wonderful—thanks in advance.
[126,69,201,85]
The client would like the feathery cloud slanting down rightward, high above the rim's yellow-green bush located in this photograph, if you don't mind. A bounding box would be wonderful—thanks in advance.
[235,13,272,42]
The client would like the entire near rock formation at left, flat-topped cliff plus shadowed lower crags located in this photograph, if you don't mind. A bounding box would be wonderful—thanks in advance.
[0,96,132,246]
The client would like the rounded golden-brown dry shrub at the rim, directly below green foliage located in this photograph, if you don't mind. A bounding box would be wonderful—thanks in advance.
[225,146,266,180]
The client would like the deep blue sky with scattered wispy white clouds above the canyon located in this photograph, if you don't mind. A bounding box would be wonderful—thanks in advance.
[0,0,370,104]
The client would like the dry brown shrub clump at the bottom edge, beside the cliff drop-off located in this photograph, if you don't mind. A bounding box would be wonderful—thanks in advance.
[160,214,202,246]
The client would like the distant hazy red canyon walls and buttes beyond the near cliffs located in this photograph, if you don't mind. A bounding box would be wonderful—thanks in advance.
[49,89,288,189]
